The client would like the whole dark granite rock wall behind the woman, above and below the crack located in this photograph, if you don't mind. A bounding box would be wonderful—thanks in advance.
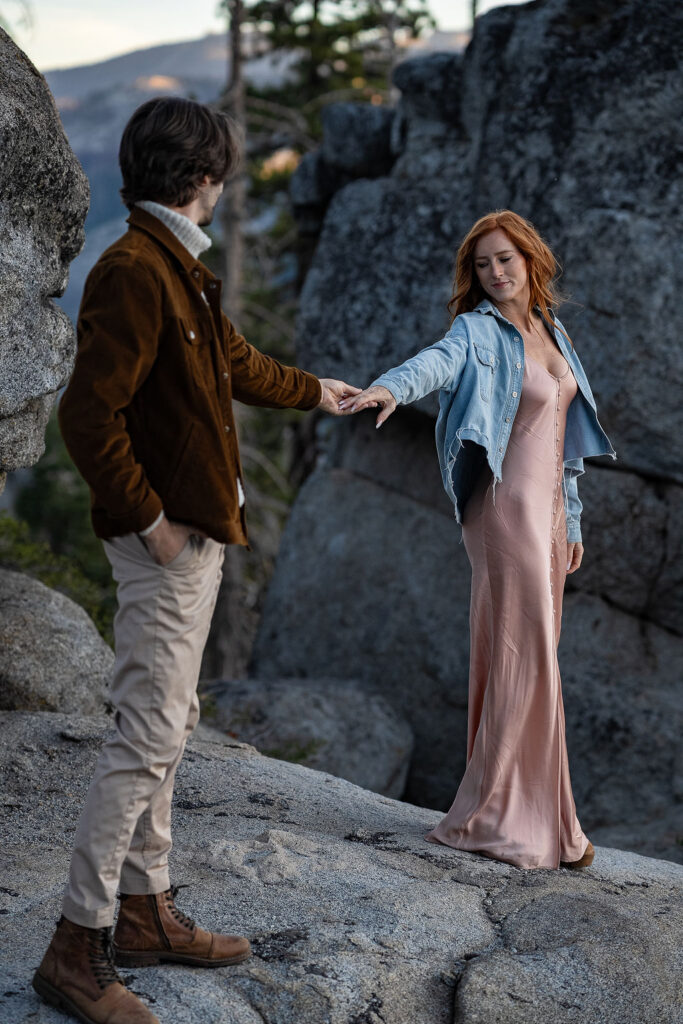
[254,0,683,839]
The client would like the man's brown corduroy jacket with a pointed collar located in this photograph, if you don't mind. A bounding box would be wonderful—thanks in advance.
[59,208,322,544]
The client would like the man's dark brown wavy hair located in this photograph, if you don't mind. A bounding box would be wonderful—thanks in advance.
[119,96,241,210]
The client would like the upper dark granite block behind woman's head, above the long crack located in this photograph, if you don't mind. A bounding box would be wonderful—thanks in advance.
[298,0,683,482]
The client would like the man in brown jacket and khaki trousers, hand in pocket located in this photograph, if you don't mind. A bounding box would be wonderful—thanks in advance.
[34,98,358,1024]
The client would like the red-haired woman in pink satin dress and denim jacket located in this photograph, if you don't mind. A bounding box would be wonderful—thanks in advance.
[341,210,616,868]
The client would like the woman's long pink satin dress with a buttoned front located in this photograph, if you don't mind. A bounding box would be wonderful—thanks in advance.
[426,356,588,867]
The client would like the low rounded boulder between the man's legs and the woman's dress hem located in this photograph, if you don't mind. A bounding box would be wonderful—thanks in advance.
[203,679,413,797]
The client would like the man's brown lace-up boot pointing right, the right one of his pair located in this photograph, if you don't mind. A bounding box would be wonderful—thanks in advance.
[114,886,251,967]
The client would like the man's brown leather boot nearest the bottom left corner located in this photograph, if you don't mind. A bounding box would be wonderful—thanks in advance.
[33,916,160,1024]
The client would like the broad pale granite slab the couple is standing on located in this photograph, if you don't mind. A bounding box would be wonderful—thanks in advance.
[0,712,683,1024]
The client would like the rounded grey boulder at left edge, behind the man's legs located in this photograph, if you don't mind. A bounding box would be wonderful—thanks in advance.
[0,569,114,715]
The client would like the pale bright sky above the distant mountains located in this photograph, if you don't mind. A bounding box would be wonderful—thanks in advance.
[0,0,521,71]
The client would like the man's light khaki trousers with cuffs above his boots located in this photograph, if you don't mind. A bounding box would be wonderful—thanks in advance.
[63,534,223,928]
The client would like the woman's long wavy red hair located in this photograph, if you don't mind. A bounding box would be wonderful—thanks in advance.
[449,210,573,347]
